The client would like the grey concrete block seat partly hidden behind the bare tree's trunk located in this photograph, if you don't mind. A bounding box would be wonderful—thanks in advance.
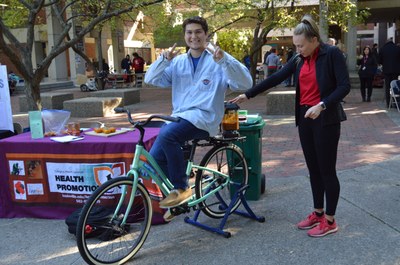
[19,92,74,112]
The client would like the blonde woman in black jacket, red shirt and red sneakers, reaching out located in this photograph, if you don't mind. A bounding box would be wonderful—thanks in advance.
[231,16,350,237]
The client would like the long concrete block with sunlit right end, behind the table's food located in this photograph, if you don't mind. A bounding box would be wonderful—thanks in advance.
[64,97,122,117]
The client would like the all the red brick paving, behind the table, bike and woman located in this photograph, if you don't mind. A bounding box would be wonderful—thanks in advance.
[12,84,400,178]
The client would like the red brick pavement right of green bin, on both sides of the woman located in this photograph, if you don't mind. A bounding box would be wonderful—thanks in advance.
[243,88,400,177]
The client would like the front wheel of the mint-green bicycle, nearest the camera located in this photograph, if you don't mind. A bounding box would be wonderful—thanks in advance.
[76,177,152,265]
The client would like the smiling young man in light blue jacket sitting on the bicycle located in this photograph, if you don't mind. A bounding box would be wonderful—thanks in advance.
[144,17,253,208]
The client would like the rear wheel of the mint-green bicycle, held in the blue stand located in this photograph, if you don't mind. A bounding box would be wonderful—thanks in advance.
[195,144,248,218]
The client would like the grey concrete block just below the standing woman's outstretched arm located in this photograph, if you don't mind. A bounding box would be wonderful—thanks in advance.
[266,90,296,115]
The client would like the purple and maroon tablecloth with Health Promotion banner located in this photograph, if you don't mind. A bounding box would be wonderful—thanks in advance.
[0,128,159,219]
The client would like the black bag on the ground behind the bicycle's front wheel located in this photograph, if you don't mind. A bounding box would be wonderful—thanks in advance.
[65,206,114,237]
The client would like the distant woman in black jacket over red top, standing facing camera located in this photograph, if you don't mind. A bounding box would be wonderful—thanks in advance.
[357,46,378,102]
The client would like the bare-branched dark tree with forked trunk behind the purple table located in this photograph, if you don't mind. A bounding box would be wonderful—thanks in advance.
[0,0,163,109]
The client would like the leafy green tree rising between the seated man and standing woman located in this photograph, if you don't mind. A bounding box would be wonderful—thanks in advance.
[159,0,368,82]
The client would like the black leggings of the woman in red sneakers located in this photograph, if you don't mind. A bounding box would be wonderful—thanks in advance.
[298,106,340,215]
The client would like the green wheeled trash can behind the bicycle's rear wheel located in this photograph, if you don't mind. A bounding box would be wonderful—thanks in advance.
[235,115,265,201]
